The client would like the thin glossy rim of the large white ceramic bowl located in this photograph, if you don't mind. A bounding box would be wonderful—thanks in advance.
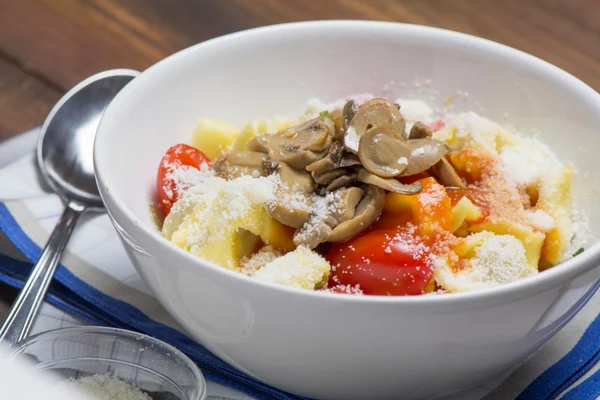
[94,20,600,308]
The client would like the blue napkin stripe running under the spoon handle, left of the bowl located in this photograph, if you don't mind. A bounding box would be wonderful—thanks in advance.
[0,203,307,400]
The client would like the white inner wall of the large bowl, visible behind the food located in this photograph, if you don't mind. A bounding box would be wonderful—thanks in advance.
[95,21,600,282]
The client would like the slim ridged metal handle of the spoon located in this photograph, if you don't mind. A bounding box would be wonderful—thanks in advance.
[0,202,85,345]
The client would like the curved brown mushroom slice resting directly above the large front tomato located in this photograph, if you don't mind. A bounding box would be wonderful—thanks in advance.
[327,185,385,242]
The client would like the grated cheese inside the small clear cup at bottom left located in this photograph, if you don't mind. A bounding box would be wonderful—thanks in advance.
[58,375,152,400]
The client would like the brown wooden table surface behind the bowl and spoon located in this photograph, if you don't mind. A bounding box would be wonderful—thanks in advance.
[0,0,600,314]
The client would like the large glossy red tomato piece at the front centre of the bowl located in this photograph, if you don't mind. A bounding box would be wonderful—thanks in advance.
[326,229,433,296]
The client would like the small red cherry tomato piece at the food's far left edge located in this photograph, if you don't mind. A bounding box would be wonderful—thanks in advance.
[156,143,210,215]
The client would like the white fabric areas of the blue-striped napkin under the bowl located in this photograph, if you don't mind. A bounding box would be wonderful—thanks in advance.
[0,130,600,400]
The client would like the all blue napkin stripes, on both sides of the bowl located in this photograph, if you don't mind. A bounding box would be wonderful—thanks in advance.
[0,203,600,400]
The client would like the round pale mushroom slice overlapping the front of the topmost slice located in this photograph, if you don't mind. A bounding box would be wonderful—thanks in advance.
[358,127,411,178]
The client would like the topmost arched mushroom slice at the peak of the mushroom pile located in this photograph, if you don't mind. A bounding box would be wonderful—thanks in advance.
[344,98,407,154]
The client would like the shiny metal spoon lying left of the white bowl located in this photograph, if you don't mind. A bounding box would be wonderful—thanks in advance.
[0,69,139,344]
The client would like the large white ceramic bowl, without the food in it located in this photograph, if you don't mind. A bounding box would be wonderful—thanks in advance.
[95,21,600,399]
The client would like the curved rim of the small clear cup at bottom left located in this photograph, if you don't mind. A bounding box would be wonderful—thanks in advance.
[8,325,207,400]
